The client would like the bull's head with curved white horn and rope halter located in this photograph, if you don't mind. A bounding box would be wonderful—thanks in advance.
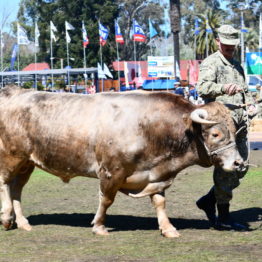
[190,108,245,172]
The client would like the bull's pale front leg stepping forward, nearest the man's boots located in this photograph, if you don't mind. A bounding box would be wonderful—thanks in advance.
[150,192,180,238]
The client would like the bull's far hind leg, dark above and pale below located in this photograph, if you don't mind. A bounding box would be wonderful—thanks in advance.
[11,161,34,231]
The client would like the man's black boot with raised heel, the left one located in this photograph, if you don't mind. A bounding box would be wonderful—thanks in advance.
[196,187,216,227]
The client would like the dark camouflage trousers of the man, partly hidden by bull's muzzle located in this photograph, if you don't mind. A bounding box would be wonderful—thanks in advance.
[213,133,248,204]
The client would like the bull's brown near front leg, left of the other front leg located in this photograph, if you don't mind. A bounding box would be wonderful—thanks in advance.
[92,164,124,235]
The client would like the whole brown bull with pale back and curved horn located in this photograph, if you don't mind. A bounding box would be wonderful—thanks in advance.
[0,86,244,237]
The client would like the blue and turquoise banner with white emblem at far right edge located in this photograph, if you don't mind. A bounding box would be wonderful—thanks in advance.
[246,52,262,75]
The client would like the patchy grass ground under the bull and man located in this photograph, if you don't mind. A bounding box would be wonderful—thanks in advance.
[0,153,262,262]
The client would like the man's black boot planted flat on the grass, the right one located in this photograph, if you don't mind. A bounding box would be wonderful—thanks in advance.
[216,204,248,231]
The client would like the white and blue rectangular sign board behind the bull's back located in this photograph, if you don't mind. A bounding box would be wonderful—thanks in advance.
[147,56,174,78]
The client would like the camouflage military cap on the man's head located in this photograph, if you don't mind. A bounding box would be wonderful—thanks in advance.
[217,25,239,45]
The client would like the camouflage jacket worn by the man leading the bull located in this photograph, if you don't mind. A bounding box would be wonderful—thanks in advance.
[197,51,254,124]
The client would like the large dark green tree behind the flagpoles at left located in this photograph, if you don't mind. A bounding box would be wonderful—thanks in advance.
[18,0,118,67]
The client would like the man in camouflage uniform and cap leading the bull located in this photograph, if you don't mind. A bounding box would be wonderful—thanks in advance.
[196,25,256,230]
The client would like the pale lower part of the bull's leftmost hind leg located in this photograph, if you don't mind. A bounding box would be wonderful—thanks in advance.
[0,177,13,230]
